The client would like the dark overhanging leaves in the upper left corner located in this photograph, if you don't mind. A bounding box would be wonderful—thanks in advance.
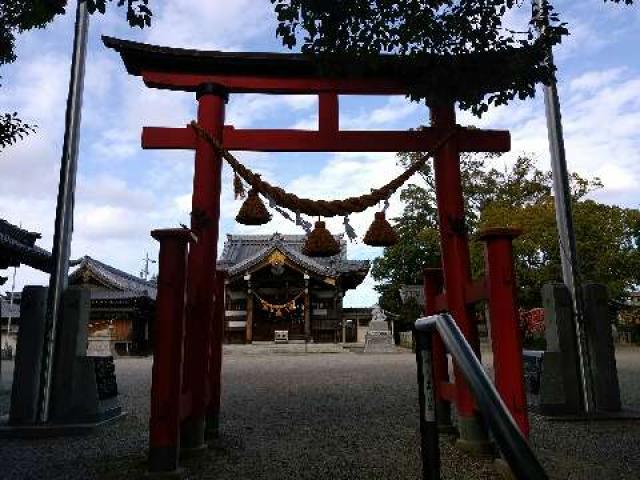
[0,0,152,149]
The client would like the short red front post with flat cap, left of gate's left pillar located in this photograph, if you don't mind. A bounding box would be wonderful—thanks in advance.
[149,228,196,473]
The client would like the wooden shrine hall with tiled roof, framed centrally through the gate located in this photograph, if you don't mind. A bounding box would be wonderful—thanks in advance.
[218,233,370,343]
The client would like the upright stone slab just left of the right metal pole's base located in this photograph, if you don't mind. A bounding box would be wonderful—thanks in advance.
[540,283,582,415]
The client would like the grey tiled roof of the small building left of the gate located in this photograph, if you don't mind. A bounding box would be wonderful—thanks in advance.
[69,256,157,299]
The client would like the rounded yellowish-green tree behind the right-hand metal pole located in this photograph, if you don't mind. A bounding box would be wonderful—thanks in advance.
[481,196,640,307]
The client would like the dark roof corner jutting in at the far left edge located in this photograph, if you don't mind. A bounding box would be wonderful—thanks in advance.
[0,219,51,273]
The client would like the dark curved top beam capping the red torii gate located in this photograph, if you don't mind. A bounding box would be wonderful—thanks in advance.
[102,36,532,98]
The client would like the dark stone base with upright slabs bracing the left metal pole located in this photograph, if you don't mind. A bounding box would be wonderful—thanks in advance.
[5,287,123,437]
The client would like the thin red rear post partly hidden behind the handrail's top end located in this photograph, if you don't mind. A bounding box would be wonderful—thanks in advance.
[422,268,452,430]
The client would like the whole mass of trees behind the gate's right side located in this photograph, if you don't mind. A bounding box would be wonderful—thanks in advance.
[372,154,640,310]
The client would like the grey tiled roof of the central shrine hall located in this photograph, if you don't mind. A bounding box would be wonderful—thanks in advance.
[218,233,370,277]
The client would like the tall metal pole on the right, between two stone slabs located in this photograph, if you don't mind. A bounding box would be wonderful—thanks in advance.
[534,0,594,414]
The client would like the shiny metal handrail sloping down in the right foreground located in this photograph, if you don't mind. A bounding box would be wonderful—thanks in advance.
[415,313,548,480]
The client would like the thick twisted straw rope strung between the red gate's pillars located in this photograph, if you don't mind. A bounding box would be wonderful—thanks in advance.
[190,121,461,217]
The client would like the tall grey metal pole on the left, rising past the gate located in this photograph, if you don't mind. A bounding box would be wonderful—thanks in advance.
[38,0,89,423]
